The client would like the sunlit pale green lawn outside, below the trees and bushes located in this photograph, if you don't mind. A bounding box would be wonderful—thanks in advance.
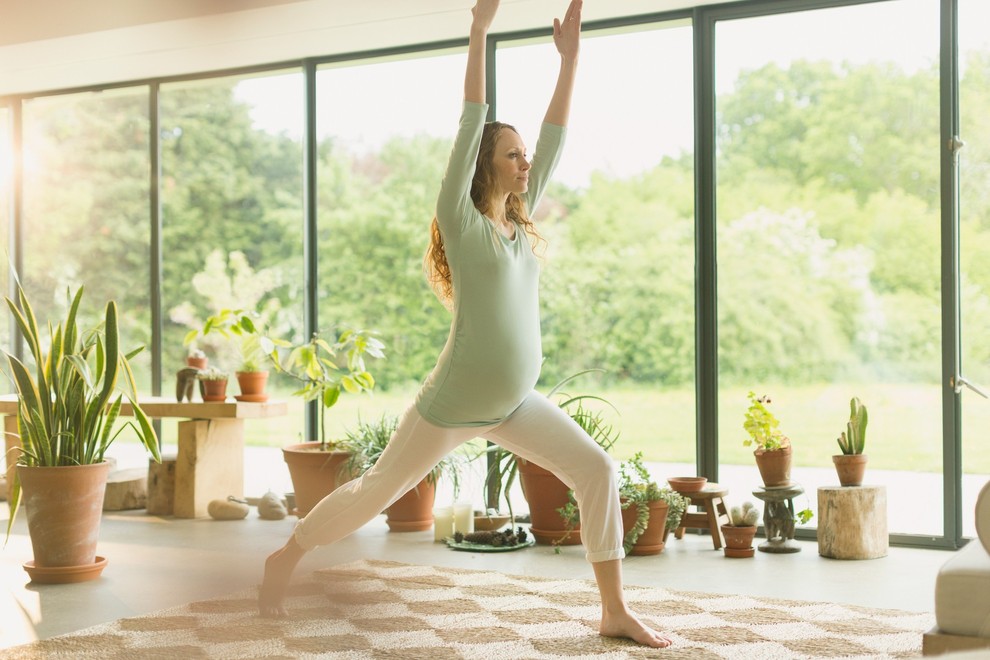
[147,385,990,474]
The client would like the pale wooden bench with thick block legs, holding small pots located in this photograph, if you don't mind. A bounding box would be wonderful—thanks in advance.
[0,395,288,518]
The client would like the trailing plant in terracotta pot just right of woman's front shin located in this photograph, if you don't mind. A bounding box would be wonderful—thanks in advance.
[619,452,691,555]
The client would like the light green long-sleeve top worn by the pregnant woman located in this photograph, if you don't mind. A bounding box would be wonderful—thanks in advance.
[416,101,565,427]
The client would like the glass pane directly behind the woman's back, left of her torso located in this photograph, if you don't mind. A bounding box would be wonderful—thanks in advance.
[317,51,466,439]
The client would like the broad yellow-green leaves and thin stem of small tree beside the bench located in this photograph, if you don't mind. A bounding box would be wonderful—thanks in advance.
[271,330,385,451]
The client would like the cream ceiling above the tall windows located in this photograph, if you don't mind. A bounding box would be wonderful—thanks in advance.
[0,0,728,96]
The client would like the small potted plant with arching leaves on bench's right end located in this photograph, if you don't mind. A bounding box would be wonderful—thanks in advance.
[184,309,290,403]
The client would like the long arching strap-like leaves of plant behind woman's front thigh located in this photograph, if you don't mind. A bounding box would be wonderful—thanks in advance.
[484,369,619,520]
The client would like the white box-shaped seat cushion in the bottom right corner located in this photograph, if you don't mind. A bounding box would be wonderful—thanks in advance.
[935,541,990,637]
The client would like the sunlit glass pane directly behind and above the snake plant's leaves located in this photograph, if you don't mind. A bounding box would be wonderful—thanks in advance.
[20,87,151,391]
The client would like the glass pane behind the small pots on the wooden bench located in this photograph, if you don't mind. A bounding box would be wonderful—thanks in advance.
[160,71,304,447]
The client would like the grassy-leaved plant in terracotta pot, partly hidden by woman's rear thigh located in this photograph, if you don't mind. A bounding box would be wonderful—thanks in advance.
[337,414,460,532]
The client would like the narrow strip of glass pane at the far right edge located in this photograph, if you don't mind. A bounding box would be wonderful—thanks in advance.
[959,0,990,537]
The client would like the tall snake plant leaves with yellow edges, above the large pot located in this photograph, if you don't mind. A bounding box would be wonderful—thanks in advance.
[4,285,161,535]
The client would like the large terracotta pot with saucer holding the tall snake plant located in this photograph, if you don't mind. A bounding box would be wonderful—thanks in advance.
[17,461,110,582]
